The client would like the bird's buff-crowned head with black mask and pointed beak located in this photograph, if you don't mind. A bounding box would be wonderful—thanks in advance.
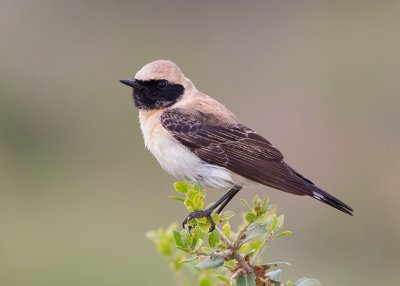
[121,60,194,110]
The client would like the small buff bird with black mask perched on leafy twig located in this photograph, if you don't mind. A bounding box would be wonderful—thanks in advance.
[120,60,353,231]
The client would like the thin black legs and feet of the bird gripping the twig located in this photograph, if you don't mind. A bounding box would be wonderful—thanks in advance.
[182,185,242,232]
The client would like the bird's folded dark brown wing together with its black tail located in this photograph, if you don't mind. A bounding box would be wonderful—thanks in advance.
[161,108,351,213]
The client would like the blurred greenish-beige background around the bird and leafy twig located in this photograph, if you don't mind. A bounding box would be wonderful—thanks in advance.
[0,0,400,286]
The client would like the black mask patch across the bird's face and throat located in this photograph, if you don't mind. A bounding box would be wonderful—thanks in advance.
[133,79,185,110]
